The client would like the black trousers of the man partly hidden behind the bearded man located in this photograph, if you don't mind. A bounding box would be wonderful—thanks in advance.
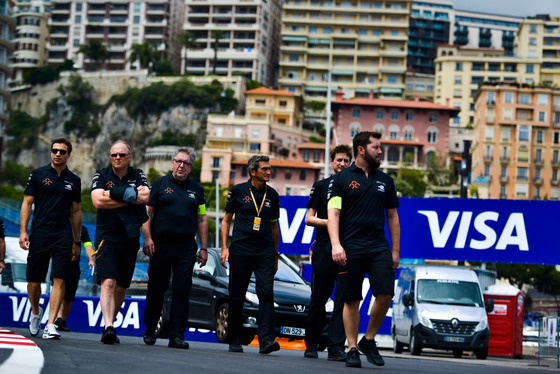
[305,242,346,352]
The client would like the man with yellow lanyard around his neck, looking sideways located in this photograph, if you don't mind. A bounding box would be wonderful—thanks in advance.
[220,155,280,354]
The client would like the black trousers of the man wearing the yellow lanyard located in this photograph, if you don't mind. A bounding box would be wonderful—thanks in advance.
[228,254,276,345]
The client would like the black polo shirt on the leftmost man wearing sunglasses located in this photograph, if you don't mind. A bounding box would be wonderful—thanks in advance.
[23,164,82,240]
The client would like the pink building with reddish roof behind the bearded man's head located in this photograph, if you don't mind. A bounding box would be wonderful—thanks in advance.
[332,90,459,172]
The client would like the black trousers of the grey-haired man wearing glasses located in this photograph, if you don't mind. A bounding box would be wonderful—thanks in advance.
[144,238,197,339]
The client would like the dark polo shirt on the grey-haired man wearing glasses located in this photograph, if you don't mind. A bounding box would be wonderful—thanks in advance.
[147,173,206,240]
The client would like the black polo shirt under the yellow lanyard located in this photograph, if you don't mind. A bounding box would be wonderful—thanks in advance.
[226,180,280,256]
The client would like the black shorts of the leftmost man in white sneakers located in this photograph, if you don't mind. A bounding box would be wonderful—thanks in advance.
[26,237,72,283]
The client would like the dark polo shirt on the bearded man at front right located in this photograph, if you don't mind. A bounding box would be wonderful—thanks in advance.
[328,163,399,258]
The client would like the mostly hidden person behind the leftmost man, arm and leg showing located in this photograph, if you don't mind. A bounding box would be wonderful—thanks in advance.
[54,225,95,331]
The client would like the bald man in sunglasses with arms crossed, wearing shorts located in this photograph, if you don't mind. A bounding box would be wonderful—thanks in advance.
[91,140,150,344]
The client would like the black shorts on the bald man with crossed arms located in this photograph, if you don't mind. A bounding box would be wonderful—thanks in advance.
[95,238,140,288]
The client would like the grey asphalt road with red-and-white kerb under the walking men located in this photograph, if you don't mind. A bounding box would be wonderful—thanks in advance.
[0,328,559,374]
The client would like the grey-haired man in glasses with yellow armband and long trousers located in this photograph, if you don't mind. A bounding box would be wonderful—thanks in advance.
[142,147,208,349]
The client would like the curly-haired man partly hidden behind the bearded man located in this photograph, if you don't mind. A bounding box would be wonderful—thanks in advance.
[304,144,352,361]
